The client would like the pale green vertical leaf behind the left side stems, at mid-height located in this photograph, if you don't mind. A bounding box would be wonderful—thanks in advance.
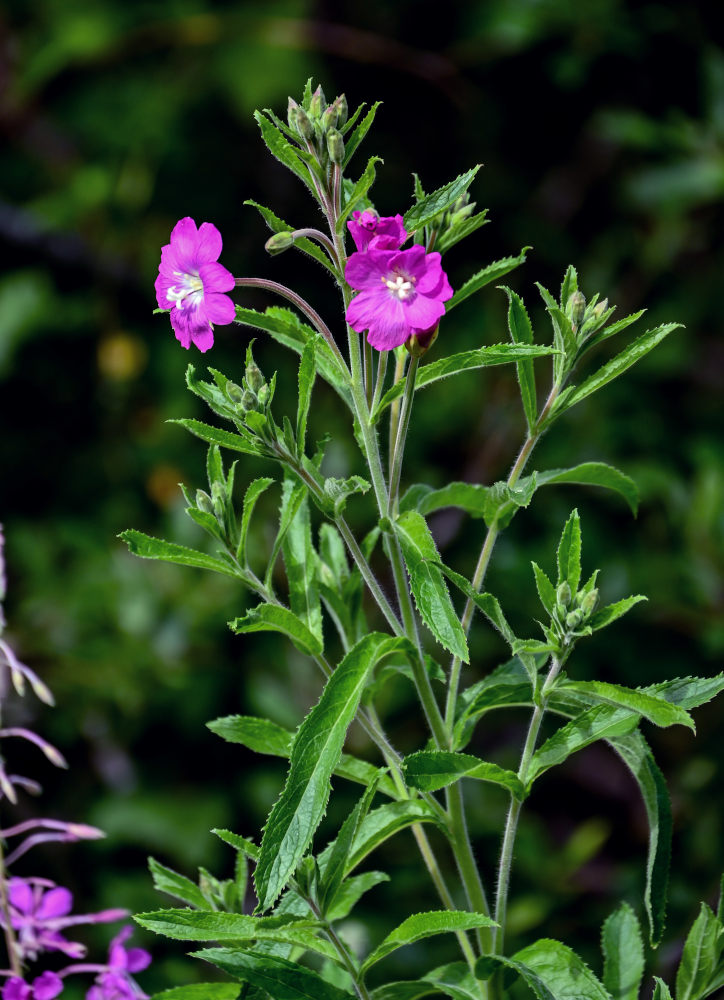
[282,488,324,648]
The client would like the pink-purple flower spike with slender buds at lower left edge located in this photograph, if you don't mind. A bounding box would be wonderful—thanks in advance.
[0,525,151,1000]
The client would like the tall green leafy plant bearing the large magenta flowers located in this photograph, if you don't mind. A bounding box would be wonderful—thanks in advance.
[123,85,724,1000]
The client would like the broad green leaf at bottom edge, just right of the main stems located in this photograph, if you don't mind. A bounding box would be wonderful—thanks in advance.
[475,938,611,1000]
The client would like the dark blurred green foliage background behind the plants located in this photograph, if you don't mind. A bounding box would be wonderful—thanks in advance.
[0,0,724,992]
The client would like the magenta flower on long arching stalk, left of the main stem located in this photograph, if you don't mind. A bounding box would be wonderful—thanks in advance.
[155,216,236,351]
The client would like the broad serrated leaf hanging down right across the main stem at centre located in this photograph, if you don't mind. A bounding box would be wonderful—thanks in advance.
[393,510,468,663]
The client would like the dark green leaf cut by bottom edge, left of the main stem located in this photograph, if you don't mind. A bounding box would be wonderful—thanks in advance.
[193,948,352,1000]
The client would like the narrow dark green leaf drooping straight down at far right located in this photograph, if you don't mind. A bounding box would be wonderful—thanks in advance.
[607,731,672,947]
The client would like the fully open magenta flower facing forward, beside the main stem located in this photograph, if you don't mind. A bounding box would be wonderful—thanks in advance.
[345,246,453,351]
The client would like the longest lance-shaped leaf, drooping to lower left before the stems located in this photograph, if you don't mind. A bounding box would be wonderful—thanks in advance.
[254,632,409,911]
